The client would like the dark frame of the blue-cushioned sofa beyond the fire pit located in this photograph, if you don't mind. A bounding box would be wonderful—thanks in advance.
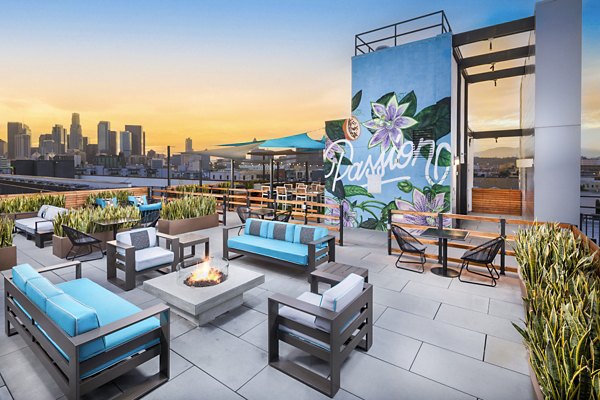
[223,224,335,274]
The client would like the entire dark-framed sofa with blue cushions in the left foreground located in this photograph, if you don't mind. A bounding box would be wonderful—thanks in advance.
[4,261,170,399]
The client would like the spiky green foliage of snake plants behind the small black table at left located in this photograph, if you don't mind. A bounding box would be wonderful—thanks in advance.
[53,206,141,237]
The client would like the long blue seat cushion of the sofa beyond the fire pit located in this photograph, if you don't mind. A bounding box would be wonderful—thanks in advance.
[227,235,308,265]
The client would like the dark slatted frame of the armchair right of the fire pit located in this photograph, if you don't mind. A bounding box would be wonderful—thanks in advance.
[268,271,373,397]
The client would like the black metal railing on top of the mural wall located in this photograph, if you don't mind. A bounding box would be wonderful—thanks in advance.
[354,10,452,56]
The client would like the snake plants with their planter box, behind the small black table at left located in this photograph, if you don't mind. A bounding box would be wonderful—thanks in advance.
[52,206,140,258]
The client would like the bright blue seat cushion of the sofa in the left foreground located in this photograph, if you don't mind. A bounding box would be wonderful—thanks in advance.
[58,278,160,351]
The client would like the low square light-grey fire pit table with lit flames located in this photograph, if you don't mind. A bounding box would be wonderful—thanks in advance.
[143,257,265,325]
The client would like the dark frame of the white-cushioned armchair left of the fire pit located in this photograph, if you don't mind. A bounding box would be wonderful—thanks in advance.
[106,232,179,291]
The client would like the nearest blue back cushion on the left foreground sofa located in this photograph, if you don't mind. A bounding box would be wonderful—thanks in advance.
[46,293,105,360]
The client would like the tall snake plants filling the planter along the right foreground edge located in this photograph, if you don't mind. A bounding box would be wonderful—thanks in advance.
[515,225,600,400]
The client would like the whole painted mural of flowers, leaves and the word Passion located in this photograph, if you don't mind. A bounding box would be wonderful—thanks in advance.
[323,91,452,231]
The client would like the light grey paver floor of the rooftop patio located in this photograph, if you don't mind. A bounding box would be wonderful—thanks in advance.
[0,213,534,399]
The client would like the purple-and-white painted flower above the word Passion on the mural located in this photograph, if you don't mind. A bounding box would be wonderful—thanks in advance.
[363,95,417,151]
